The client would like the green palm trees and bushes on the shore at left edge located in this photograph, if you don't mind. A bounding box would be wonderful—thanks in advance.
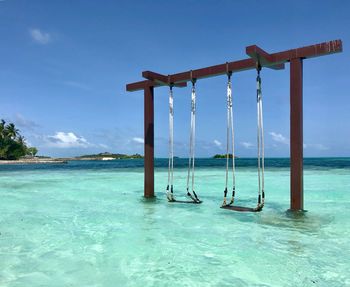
[0,120,38,160]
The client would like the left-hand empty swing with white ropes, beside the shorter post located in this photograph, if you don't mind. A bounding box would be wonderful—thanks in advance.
[166,75,202,204]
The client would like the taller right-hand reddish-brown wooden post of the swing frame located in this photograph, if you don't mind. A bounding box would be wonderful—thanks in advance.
[290,58,304,211]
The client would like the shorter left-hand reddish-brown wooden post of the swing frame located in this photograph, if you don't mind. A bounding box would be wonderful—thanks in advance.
[144,86,154,198]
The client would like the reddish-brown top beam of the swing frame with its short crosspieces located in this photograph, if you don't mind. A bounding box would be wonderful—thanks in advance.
[126,40,343,91]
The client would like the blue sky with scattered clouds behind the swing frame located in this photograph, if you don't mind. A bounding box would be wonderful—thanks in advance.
[0,0,350,157]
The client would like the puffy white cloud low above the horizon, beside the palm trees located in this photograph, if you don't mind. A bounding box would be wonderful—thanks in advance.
[45,132,92,148]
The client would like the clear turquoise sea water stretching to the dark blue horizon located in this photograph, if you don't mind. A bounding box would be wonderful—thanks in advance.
[0,158,350,287]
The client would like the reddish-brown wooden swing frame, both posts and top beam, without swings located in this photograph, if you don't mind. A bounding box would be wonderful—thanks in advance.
[126,40,342,211]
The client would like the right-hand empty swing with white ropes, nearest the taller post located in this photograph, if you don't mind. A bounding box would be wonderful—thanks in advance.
[221,63,265,212]
